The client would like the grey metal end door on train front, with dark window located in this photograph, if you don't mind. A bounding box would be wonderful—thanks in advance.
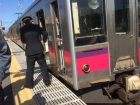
[108,0,138,73]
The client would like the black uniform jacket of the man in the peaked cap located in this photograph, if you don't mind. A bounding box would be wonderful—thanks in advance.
[20,24,48,56]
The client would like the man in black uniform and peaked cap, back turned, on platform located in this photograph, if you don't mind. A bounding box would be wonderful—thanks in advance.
[20,16,51,88]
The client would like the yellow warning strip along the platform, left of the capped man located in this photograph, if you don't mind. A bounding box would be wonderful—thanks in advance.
[6,39,37,105]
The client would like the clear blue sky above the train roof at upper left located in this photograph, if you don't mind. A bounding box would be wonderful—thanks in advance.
[0,0,35,32]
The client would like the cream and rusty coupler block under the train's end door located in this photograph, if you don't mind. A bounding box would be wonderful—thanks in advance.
[117,74,140,102]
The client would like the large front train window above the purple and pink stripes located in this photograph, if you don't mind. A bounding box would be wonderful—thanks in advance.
[71,0,107,46]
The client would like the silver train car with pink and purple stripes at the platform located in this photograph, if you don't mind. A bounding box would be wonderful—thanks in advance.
[7,0,140,103]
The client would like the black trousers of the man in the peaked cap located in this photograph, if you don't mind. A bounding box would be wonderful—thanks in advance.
[26,53,49,88]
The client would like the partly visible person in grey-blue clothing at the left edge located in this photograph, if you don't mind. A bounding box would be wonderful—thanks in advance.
[0,32,11,105]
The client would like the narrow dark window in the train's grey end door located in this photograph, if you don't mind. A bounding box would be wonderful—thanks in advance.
[114,0,130,34]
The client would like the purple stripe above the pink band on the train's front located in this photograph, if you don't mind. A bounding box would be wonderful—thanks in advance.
[76,47,108,59]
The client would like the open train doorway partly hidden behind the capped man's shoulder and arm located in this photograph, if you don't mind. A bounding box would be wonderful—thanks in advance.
[37,10,49,55]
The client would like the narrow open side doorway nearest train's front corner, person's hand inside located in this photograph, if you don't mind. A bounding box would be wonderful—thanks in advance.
[51,2,65,74]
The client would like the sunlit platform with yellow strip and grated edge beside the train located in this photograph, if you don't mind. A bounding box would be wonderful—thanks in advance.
[3,39,86,105]
